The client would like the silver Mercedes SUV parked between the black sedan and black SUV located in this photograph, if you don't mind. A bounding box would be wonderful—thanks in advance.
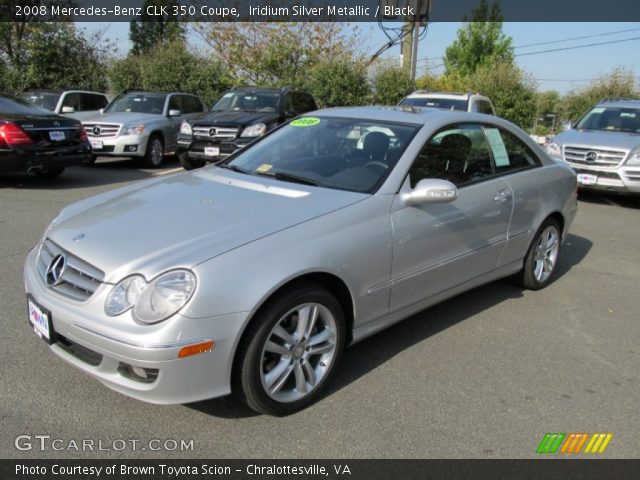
[83,91,205,168]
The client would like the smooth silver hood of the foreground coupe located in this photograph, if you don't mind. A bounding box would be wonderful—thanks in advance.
[46,167,368,282]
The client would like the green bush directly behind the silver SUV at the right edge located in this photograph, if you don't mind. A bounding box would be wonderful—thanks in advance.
[562,67,640,122]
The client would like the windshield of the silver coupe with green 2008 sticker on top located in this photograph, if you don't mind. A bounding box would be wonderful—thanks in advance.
[226,116,420,193]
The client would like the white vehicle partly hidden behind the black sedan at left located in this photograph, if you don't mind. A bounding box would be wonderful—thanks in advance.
[20,90,109,120]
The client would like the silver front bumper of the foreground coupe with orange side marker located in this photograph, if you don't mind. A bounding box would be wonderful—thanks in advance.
[24,249,247,404]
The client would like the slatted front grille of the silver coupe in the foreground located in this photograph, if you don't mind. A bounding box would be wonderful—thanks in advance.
[37,238,104,302]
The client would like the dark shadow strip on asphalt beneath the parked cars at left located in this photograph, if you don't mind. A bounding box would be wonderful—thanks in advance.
[0,159,179,190]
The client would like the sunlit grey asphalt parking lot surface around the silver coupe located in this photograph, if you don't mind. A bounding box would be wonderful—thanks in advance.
[0,159,640,459]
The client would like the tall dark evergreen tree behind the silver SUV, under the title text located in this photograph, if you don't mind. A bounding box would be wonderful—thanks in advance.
[129,0,185,55]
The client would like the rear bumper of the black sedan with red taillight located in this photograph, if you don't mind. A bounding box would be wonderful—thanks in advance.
[0,144,91,172]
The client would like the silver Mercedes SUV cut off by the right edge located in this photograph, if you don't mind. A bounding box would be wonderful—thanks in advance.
[547,100,640,195]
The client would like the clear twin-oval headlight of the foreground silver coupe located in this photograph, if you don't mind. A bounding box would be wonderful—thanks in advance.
[104,270,196,323]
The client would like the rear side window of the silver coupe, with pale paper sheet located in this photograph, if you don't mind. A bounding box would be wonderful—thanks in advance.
[484,127,541,175]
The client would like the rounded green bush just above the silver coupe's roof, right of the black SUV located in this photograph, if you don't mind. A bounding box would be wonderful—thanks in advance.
[307,57,371,107]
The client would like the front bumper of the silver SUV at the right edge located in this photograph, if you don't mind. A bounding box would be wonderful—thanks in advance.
[568,162,640,195]
